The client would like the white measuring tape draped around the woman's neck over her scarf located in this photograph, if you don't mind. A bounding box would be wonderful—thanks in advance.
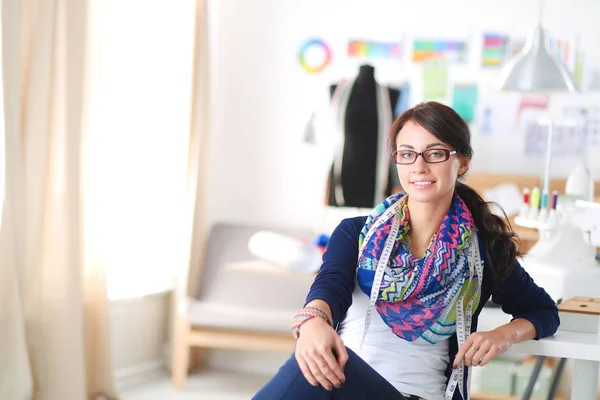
[358,200,483,400]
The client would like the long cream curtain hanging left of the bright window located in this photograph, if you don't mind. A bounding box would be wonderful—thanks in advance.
[0,0,117,400]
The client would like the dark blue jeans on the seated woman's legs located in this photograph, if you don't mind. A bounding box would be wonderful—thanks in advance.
[252,347,418,400]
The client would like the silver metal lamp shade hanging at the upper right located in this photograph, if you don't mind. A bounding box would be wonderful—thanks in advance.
[494,25,579,93]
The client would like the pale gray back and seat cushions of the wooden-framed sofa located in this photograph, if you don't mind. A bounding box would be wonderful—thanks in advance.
[188,223,314,332]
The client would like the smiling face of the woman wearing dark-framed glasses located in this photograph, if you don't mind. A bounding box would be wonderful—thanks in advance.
[396,121,470,203]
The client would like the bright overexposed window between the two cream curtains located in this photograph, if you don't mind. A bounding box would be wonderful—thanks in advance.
[84,0,195,299]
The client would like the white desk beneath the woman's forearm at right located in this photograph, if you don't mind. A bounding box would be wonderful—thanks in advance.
[508,329,600,400]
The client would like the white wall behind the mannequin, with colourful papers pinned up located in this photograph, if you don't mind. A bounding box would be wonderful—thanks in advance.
[208,0,600,231]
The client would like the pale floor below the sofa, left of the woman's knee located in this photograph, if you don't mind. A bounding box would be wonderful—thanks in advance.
[121,370,269,400]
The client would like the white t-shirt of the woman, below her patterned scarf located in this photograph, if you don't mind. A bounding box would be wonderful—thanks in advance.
[338,285,449,400]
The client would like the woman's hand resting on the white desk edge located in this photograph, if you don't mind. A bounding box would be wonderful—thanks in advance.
[453,328,512,368]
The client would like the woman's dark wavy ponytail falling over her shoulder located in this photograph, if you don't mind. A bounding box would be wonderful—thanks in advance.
[455,181,521,286]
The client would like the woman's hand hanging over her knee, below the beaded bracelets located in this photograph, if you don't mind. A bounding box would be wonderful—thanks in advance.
[295,318,348,390]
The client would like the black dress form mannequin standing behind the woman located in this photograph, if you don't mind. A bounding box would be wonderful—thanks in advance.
[326,65,400,208]
